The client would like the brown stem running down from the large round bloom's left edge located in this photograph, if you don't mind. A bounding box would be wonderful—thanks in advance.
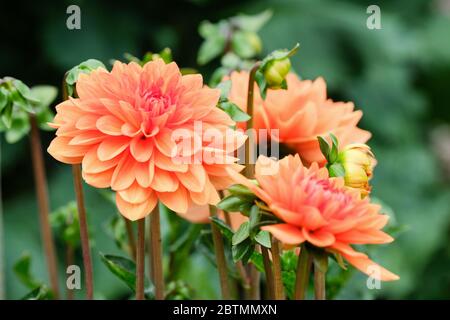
[72,164,94,300]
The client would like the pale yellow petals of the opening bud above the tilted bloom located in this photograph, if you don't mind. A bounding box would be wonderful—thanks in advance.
[339,143,376,196]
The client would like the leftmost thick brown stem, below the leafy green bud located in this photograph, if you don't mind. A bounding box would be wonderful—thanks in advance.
[30,114,59,299]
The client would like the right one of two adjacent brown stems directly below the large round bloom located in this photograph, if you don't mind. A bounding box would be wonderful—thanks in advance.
[150,205,165,300]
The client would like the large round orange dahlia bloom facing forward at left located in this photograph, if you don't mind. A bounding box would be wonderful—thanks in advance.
[48,59,246,220]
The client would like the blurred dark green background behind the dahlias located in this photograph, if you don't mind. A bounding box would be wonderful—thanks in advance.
[0,0,450,299]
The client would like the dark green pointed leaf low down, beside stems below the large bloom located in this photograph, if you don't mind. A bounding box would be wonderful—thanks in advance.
[100,252,153,298]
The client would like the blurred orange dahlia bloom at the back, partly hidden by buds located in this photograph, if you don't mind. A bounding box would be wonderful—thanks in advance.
[229,71,371,164]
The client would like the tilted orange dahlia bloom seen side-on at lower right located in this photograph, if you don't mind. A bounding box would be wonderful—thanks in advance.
[230,155,398,281]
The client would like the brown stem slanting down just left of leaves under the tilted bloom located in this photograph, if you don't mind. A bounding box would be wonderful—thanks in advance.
[209,206,231,300]
